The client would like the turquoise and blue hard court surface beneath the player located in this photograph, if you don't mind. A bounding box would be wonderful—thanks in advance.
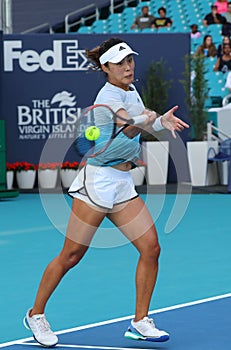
[0,194,231,350]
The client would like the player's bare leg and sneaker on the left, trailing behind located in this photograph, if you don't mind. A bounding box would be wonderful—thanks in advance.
[25,198,106,346]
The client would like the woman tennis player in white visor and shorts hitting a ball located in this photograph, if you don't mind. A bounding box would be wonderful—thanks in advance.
[24,38,188,347]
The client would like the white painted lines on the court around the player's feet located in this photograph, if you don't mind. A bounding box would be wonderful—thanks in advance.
[0,293,231,350]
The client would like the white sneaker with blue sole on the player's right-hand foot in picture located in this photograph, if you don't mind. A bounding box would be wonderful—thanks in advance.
[124,316,169,342]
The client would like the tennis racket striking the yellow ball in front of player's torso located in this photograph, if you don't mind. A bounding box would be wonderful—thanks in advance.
[76,104,147,158]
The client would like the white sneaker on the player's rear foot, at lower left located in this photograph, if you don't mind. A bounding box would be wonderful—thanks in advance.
[23,310,58,347]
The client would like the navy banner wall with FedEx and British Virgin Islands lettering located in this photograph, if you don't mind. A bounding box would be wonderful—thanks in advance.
[0,34,190,163]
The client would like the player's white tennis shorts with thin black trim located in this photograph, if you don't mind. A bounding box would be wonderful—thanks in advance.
[68,165,138,209]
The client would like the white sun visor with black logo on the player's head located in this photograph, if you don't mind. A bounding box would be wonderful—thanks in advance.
[99,43,139,64]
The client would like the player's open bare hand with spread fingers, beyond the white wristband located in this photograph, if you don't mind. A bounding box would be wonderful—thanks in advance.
[161,106,189,138]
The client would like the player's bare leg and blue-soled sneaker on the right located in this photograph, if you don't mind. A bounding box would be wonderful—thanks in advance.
[108,197,169,341]
